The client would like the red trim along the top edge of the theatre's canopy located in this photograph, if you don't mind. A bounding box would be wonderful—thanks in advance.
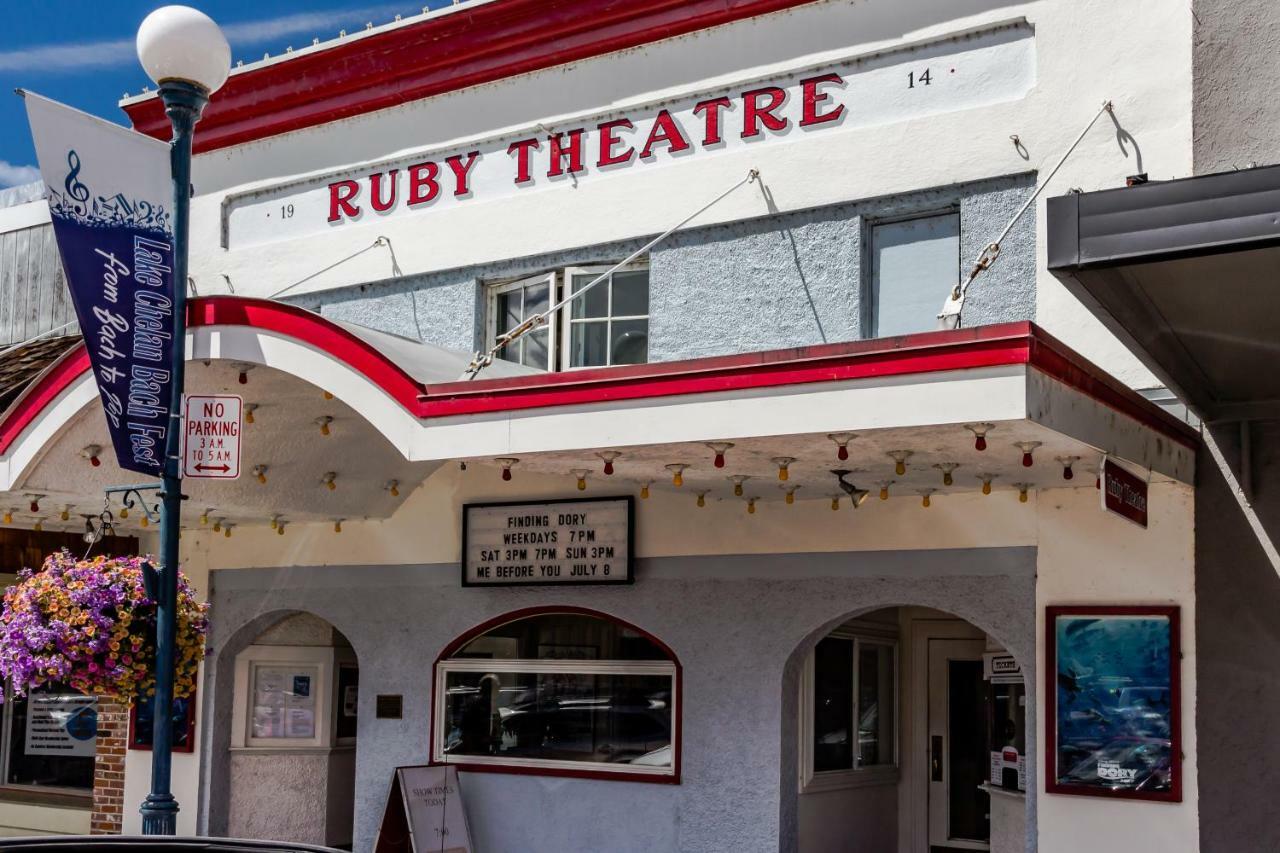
[0,312,1199,453]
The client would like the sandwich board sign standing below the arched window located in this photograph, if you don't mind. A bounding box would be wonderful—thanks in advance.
[374,765,475,853]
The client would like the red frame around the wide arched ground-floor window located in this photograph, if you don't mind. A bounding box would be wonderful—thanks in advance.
[426,605,685,785]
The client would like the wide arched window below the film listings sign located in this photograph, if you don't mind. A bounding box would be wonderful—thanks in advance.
[431,608,680,781]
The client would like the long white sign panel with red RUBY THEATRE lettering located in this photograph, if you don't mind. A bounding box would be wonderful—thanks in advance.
[224,22,1036,247]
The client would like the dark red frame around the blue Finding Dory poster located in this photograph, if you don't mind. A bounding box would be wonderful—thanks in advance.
[1044,605,1183,803]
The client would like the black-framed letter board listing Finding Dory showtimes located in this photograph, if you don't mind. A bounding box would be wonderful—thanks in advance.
[462,496,635,587]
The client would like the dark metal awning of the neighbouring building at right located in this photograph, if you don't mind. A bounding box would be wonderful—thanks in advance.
[1048,165,1280,421]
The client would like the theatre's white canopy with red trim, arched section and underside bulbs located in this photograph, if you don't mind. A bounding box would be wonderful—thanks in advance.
[0,297,1197,529]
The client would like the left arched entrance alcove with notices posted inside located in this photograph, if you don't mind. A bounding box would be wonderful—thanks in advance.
[206,612,360,849]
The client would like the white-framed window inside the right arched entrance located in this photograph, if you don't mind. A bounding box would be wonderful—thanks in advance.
[801,631,897,789]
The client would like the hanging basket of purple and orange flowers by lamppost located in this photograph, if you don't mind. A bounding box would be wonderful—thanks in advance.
[0,549,209,701]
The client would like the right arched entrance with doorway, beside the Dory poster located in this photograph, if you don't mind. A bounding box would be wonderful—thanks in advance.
[782,606,1036,853]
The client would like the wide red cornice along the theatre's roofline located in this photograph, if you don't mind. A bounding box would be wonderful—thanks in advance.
[123,0,813,152]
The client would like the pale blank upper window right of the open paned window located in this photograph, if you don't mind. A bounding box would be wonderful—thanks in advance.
[870,213,960,338]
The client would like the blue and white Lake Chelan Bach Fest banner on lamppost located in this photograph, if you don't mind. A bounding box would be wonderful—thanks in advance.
[23,92,176,476]
